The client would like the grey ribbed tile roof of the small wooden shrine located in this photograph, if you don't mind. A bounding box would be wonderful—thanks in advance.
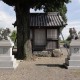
[29,12,66,27]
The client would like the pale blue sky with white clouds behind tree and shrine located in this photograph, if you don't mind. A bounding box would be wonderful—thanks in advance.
[0,0,80,39]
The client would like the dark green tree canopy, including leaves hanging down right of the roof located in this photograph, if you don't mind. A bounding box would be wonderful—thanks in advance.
[3,0,70,22]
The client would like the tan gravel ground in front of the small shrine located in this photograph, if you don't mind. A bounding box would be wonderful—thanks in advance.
[0,49,80,80]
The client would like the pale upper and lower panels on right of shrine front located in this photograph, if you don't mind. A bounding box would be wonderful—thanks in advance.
[46,29,58,50]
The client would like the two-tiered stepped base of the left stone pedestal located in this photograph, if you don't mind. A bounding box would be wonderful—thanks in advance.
[0,55,18,69]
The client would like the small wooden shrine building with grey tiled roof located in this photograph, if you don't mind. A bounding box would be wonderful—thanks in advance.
[29,12,66,51]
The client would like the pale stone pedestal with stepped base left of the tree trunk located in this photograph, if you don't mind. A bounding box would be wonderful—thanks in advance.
[0,40,18,69]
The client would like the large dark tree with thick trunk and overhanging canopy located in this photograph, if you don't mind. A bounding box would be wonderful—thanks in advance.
[2,0,70,59]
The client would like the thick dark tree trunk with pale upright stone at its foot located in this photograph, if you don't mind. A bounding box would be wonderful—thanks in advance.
[15,5,32,59]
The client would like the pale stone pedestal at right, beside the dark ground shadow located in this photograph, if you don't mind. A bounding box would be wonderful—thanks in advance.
[65,39,80,69]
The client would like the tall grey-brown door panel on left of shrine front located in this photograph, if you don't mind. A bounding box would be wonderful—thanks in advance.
[34,29,46,46]
